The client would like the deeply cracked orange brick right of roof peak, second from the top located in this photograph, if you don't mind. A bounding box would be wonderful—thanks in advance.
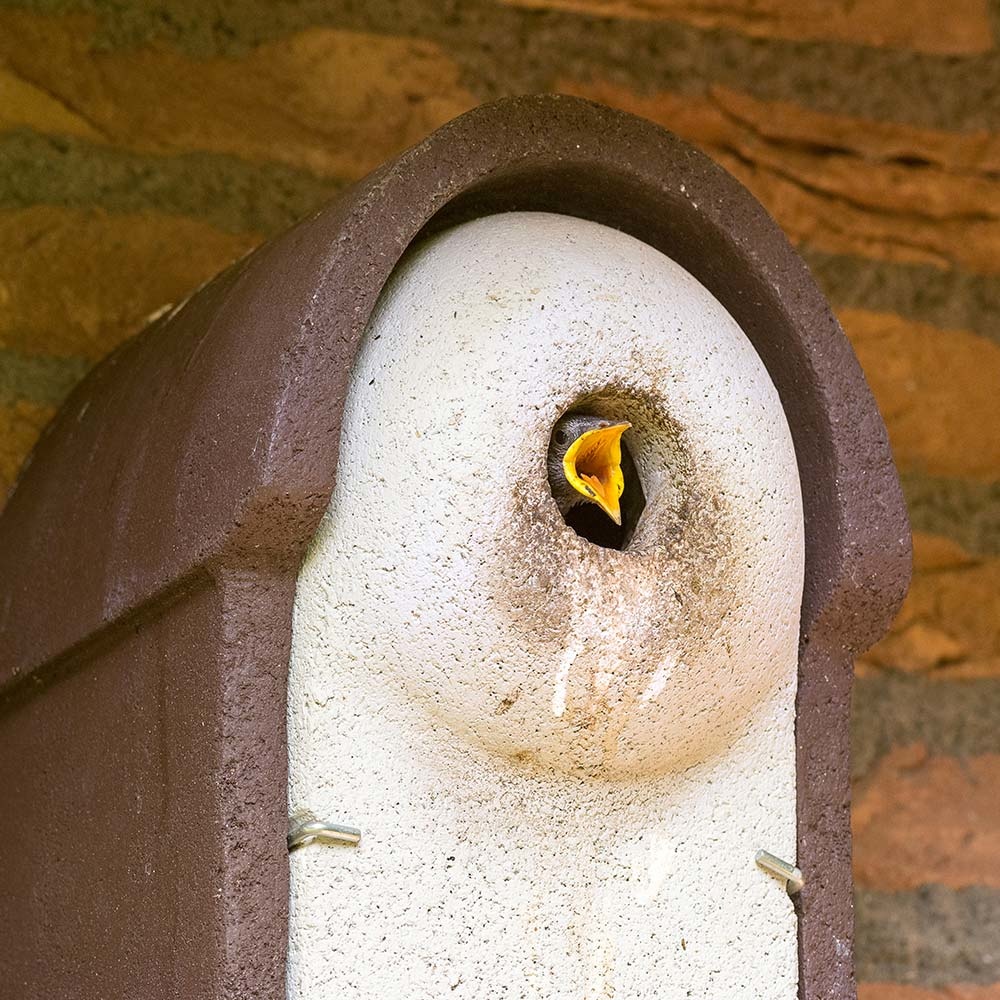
[559,80,1000,274]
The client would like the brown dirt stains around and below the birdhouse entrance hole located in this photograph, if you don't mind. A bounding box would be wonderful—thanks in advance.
[491,385,748,776]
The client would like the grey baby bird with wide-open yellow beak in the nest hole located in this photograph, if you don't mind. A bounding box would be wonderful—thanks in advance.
[547,413,632,525]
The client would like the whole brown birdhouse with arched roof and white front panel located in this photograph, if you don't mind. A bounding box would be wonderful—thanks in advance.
[0,96,909,1000]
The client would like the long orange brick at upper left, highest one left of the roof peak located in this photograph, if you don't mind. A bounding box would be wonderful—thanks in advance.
[0,10,476,178]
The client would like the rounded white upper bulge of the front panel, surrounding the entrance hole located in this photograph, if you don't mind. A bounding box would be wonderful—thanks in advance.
[305,213,804,779]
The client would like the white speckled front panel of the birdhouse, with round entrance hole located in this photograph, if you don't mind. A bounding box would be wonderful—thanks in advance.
[288,213,803,1000]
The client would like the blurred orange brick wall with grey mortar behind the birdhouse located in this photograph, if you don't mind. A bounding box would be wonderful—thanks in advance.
[0,0,1000,1000]
